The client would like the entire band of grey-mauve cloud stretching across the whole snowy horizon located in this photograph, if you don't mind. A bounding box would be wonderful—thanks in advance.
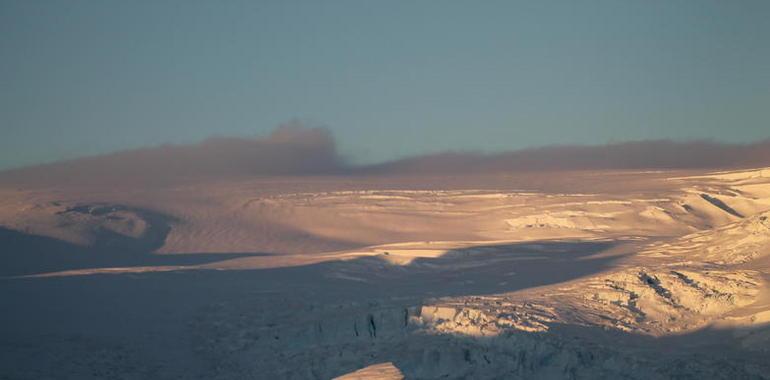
[0,123,770,186]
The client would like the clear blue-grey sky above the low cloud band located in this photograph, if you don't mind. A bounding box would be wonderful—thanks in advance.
[0,0,770,169]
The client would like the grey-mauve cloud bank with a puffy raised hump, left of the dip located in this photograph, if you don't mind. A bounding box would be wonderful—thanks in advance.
[0,123,343,185]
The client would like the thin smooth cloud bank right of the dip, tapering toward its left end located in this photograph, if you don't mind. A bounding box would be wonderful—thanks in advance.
[359,140,770,174]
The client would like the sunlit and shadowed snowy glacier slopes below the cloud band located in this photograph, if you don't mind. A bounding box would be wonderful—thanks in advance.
[0,169,770,379]
